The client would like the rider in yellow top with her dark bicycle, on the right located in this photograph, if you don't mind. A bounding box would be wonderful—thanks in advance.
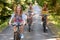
[42,2,48,32]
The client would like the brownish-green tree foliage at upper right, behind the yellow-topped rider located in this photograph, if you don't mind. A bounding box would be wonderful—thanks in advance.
[36,0,60,15]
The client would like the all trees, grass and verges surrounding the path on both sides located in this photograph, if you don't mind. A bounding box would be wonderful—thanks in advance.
[0,0,60,36]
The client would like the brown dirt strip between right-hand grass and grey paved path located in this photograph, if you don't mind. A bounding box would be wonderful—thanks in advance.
[47,20,60,40]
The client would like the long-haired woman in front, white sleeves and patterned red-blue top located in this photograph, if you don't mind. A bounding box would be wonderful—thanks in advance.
[9,5,25,38]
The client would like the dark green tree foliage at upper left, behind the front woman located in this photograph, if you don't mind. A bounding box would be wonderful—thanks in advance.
[0,0,32,25]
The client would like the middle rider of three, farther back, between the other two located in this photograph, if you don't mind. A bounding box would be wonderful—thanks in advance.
[26,3,34,31]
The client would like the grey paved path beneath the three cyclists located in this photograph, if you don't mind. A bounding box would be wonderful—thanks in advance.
[0,4,56,40]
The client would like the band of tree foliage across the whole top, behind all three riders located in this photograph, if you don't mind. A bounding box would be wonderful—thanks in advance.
[0,0,60,23]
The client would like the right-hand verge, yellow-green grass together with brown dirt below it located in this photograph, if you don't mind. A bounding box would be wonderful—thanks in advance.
[48,15,60,37]
